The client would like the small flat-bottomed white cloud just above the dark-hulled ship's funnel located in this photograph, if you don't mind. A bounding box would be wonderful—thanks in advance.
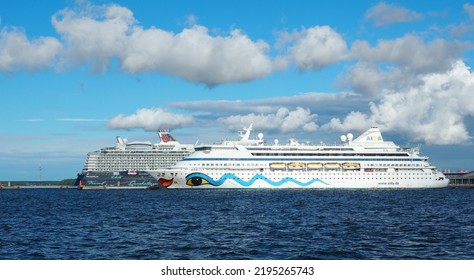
[108,108,194,130]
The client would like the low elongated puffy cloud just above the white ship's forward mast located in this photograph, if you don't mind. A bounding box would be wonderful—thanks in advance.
[218,107,318,133]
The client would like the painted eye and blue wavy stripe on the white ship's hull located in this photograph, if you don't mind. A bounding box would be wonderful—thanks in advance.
[186,173,330,187]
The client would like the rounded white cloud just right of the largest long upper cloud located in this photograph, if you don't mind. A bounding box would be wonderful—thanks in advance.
[286,26,347,70]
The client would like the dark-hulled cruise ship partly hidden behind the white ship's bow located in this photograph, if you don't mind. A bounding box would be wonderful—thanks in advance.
[75,129,194,189]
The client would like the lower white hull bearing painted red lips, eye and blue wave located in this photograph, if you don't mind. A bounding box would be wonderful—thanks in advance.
[151,167,449,189]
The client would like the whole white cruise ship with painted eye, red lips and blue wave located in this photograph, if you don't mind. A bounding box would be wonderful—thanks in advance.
[150,126,449,189]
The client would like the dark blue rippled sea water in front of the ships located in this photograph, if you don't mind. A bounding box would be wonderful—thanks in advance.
[0,188,474,260]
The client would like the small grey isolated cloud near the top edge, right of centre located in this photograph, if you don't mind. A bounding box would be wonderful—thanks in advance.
[365,2,423,27]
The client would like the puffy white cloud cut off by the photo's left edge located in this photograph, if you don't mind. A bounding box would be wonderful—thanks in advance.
[0,28,62,72]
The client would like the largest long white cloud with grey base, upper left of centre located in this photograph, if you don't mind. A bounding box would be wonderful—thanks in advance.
[121,25,272,86]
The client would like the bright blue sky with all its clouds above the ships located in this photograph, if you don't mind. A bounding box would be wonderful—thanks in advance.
[0,0,474,182]
